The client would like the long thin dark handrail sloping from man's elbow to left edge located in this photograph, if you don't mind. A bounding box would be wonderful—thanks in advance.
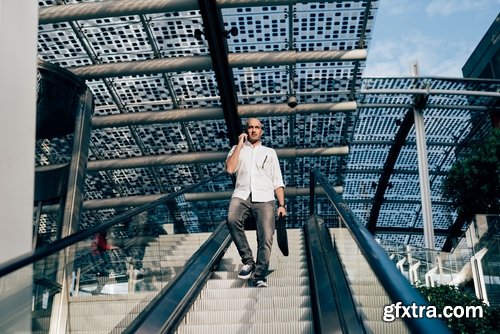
[0,171,227,277]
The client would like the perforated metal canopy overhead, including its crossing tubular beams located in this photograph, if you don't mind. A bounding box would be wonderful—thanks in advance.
[35,0,500,246]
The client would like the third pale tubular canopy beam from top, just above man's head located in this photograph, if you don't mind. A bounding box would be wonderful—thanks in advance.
[92,102,356,129]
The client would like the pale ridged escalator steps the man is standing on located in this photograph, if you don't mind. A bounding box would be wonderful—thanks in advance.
[176,229,314,334]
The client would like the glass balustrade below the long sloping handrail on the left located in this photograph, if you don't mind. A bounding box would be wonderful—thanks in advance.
[0,173,232,333]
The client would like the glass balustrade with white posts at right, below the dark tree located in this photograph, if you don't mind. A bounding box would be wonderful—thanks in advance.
[360,215,500,305]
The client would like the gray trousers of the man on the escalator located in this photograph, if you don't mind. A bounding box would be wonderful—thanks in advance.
[227,197,275,279]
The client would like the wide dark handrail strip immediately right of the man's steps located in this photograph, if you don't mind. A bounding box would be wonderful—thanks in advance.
[304,216,366,334]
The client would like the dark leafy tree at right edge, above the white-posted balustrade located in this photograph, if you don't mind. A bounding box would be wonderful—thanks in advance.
[443,129,500,217]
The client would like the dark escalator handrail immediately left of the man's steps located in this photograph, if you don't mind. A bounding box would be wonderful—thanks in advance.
[123,221,231,334]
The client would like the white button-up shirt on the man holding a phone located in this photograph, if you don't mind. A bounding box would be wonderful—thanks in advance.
[227,142,285,202]
